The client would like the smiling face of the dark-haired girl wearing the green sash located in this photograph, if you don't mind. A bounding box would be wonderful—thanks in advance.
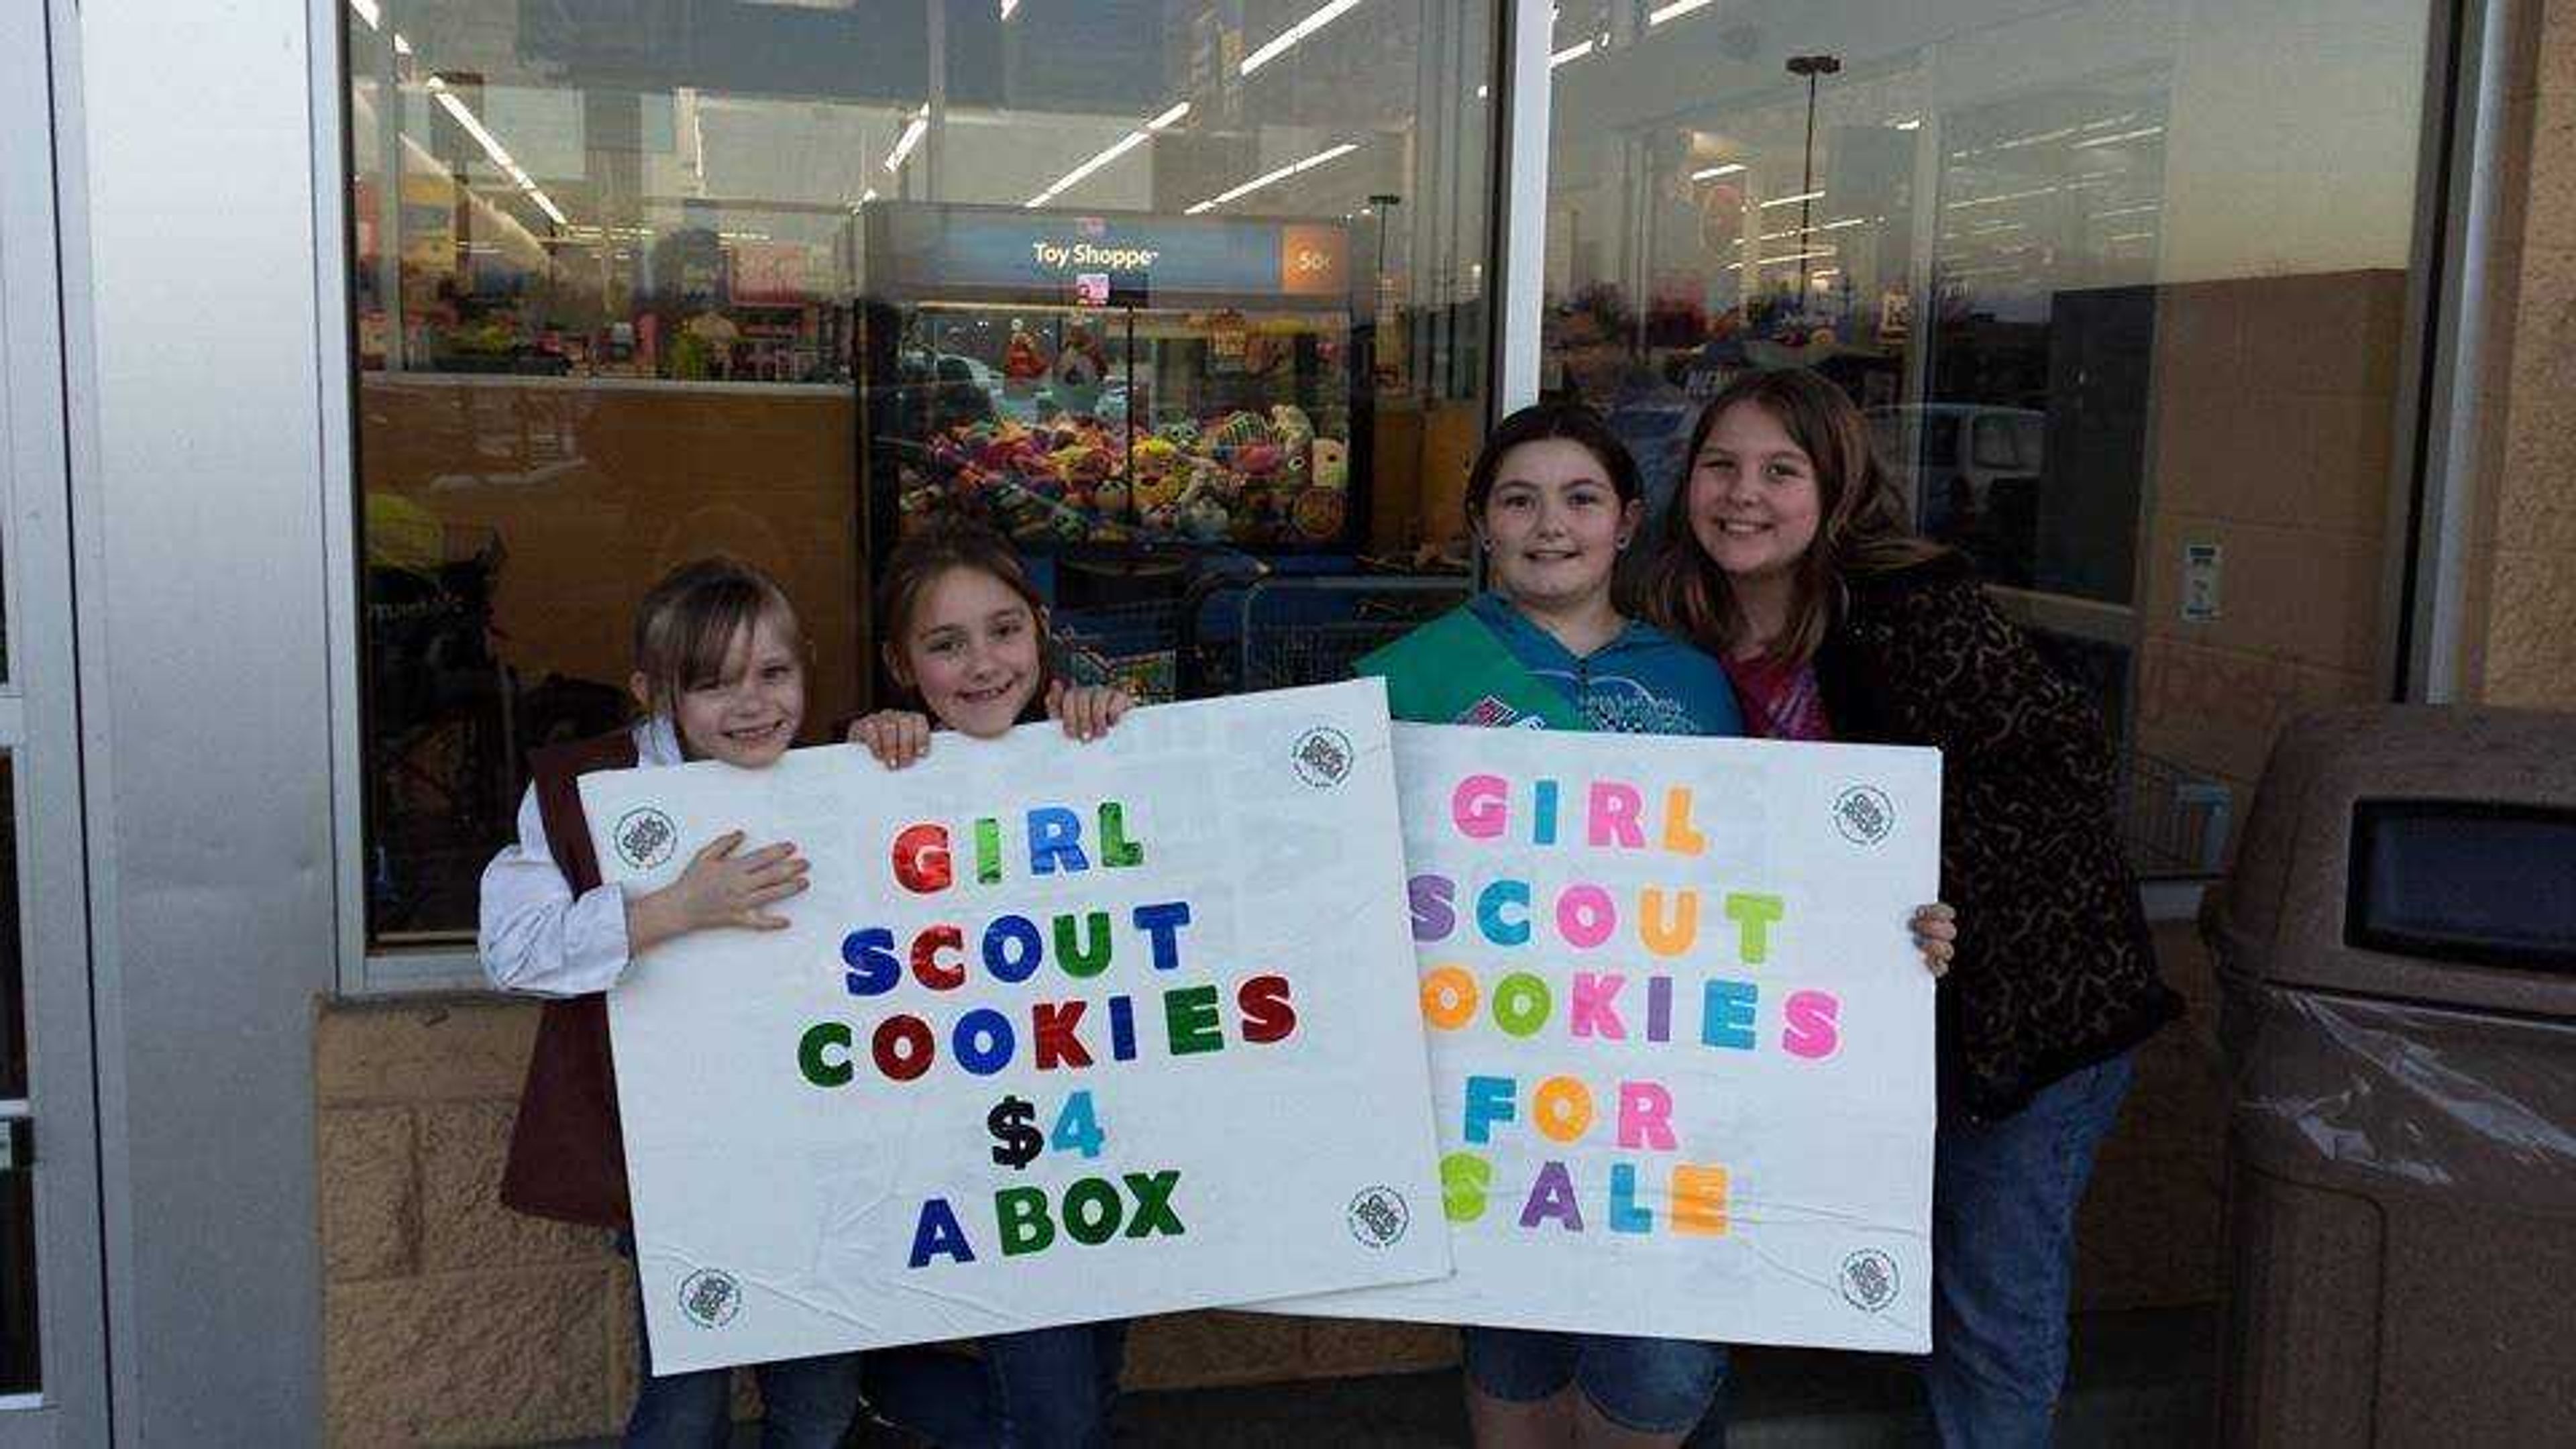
[1479,438,1644,611]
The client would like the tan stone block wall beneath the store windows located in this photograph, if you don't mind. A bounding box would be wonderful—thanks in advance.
[314,926,2220,1446]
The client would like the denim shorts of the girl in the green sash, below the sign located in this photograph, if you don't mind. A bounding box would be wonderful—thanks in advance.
[1463,1328,1726,1434]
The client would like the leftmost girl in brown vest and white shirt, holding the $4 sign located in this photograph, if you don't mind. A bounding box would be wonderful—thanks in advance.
[476,559,858,1449]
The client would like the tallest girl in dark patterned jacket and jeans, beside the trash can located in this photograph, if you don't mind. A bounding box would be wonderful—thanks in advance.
[1649,371,2180,1444]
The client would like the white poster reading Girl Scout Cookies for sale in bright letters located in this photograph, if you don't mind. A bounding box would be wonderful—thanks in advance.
[1263,724,1937,1351]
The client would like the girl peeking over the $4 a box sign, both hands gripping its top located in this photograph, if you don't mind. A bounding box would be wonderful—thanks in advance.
[850,513,1134,1449]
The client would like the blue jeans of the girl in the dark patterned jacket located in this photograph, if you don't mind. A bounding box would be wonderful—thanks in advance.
[1922,1055,2133,1449]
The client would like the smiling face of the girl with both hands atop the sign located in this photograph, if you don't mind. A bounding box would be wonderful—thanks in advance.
[886,568,1043,740]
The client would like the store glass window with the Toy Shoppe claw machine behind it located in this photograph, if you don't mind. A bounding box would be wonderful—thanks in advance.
[345,0,1494,947]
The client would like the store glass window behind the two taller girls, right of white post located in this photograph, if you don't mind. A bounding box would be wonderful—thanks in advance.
[1543,0,2439,874]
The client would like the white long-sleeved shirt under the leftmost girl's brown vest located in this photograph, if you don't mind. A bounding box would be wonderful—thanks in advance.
[474,716,680,996]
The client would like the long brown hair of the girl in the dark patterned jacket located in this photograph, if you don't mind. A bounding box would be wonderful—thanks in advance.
[1646,369,1945,663]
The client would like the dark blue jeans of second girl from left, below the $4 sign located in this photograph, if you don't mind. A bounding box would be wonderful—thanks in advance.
[865,1318,1126,1449]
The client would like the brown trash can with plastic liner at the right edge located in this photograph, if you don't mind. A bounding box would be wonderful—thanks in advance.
[2200,706,2576,1446]
